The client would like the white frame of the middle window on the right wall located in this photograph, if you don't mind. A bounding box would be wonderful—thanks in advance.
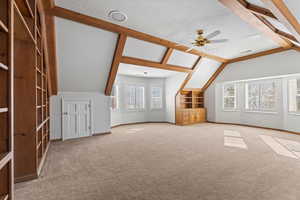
[244,79,279,114]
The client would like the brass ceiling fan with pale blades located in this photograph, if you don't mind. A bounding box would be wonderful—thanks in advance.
[177,29,228,52]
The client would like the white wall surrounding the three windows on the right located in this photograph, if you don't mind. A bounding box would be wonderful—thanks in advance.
[205,50,300,132]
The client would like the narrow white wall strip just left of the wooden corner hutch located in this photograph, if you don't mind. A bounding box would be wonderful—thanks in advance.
[165,73,187,123]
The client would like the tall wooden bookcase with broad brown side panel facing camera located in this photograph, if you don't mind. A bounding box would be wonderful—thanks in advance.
[13,0,49,182]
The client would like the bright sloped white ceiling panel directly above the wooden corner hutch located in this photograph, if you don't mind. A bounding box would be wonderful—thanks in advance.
[185,58,221,88]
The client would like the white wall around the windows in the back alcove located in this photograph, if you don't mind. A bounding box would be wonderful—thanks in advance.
[111,75,166,126]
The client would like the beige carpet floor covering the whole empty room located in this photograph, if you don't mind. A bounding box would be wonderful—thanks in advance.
[15,123,300,200]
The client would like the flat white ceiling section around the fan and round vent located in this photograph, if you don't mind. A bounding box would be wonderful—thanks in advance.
[56,0,278,58]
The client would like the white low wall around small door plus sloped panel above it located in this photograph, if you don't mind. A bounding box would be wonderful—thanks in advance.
[50,18,118,139]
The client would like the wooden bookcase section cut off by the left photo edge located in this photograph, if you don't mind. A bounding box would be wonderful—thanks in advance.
[0,0,14,199]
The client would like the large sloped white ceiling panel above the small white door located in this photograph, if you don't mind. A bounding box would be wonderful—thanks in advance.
[55,18,118,92]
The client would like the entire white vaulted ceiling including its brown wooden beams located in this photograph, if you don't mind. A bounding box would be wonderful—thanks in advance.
[47,0,300,94]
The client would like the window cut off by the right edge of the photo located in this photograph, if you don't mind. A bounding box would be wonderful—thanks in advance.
[289,79,300,112]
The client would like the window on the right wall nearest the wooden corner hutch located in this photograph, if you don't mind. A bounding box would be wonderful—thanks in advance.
[223,84,237,110]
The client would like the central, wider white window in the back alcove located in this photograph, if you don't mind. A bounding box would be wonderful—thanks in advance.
[127,85,145,110]
